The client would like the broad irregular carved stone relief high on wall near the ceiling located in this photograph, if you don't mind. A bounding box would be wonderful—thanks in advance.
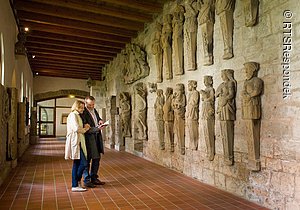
[123,44,150,84]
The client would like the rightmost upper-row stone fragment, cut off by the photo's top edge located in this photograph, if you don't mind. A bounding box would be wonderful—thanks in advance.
[243,0,259,27]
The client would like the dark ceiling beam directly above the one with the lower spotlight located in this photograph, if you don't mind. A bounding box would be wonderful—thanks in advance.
[27,48,112,62]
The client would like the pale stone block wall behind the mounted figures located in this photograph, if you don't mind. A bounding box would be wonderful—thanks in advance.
[99,0,300,209]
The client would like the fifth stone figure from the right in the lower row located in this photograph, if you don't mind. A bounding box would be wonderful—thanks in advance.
[172,83,186,155]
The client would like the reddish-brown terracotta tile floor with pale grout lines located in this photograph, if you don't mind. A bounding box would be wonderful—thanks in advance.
[0,139,265,210]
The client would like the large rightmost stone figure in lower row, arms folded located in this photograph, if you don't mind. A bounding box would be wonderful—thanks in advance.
[242,62,263,171]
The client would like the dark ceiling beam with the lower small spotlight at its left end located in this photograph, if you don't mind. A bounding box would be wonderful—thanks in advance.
[29,54,109,66]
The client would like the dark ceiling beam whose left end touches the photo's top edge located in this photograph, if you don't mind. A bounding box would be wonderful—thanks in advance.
[14,0,144,31]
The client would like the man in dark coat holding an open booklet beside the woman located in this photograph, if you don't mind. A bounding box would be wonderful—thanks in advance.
[81,96,105,187]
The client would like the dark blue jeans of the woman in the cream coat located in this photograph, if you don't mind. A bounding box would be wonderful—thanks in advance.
[72,148,88,187]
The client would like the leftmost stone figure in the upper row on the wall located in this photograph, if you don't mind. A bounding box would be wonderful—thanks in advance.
[151,22,163,83]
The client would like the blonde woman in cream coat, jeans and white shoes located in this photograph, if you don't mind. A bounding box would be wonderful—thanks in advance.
[65,100,90,192]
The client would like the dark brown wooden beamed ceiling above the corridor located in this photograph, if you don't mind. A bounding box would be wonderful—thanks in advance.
[11,0,166,80]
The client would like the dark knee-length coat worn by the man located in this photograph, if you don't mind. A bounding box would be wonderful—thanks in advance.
[81,108,104,159]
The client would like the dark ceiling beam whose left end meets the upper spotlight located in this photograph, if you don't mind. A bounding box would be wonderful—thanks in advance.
[20,21,131,43]
